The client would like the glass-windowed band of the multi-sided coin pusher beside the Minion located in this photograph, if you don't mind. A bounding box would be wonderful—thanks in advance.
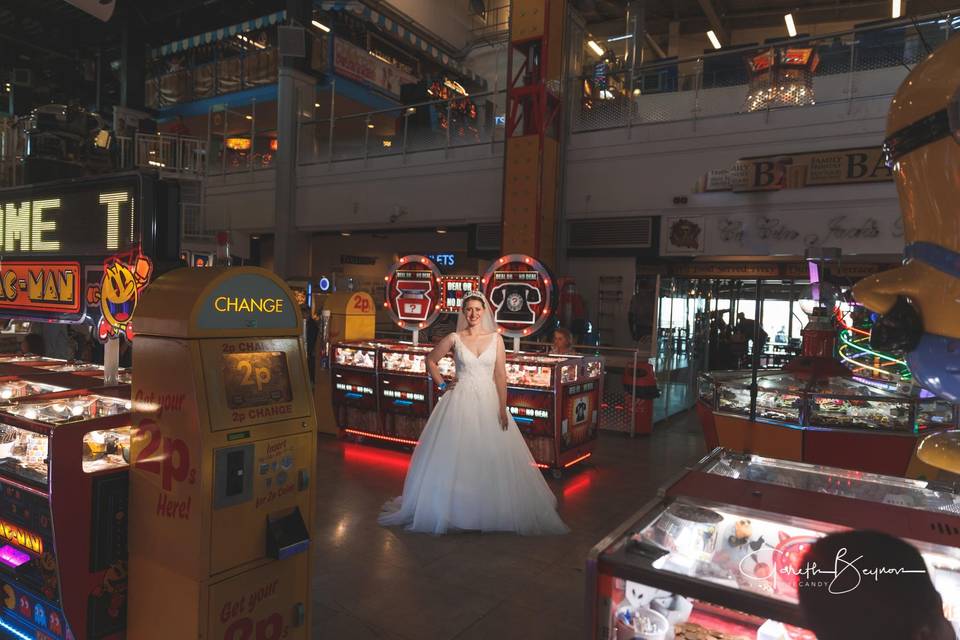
[698,371,958,433]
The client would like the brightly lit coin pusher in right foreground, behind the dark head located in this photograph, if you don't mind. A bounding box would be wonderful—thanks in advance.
[586,449,960,640]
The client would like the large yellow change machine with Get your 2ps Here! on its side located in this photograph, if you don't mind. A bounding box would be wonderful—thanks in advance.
[128,267,317,640]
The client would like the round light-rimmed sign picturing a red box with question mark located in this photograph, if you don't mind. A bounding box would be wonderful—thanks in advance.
[384,255,440,331]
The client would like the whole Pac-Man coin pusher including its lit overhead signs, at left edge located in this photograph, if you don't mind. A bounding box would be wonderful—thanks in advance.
[0,173,179,640]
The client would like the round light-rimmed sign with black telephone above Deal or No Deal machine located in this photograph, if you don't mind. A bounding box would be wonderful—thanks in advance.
[481,253,554,338]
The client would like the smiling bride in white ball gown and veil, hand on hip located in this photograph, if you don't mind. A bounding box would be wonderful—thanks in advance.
[379,292,568,535]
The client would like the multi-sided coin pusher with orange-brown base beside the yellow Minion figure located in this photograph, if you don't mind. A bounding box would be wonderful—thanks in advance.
[696,307,958,476]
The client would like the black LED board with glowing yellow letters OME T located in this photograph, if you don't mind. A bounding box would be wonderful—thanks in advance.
[0,176,140,258]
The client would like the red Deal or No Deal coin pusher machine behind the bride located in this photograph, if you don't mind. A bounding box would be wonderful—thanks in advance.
[331,255,603,474]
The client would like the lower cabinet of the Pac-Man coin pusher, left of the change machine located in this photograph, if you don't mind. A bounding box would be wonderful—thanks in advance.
[0,387,131,640]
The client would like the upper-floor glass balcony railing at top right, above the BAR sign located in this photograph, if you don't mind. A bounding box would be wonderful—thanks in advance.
[572,16,960,132]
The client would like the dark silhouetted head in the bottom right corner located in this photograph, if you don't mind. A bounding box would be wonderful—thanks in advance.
[798,531,956,640]
